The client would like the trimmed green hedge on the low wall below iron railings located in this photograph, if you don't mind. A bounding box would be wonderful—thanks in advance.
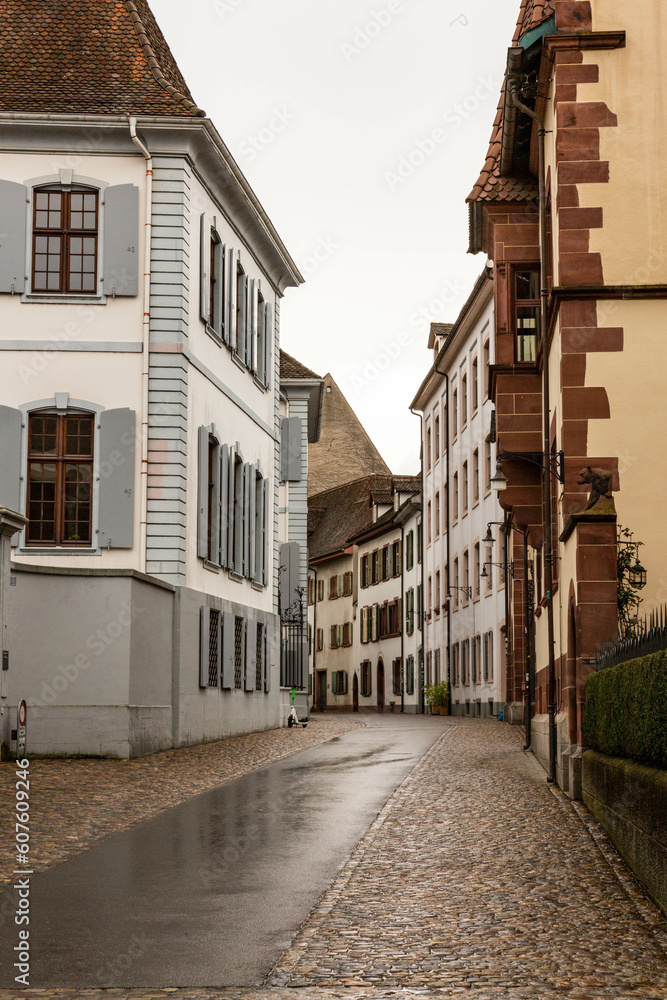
[583,651,667,769]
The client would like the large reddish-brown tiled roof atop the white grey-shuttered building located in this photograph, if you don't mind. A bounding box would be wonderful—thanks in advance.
[0,0,205,117]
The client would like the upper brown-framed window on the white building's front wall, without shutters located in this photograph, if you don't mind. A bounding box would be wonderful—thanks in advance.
[32,185,99,295]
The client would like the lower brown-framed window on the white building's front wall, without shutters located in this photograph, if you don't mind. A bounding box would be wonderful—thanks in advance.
[26,413,94,546]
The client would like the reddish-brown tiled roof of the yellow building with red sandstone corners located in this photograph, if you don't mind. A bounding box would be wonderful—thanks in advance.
[468,0,556,201]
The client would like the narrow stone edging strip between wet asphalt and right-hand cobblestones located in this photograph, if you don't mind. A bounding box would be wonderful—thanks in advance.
[264,723,458,988]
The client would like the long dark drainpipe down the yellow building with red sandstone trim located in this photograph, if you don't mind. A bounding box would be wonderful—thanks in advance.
[511,86,556,783]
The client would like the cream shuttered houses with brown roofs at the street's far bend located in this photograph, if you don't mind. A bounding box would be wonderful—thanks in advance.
[308,476,423,713]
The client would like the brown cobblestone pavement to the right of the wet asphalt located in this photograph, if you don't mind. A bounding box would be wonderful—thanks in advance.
[0,720,667,1000]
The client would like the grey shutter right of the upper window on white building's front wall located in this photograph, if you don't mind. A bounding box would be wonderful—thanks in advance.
[104,184,139,295]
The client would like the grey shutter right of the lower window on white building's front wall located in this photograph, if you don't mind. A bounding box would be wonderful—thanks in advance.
[97,409,136,549]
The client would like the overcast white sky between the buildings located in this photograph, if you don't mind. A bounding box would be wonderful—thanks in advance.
[151,0,520,473]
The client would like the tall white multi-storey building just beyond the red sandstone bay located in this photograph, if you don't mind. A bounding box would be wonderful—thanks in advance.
[412,270,506,716]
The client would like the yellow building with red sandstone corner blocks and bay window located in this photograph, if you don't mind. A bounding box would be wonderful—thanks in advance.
[469,0,667,796]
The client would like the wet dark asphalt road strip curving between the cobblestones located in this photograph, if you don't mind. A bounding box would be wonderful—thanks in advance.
[0,716,446,989]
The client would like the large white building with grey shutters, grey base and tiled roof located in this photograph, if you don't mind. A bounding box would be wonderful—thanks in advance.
[0,0,302,757]
